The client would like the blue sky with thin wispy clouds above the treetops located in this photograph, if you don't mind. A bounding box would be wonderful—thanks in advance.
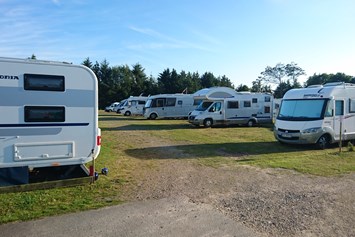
[0,0,355,86]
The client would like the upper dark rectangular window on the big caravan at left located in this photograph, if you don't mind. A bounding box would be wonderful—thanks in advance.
[24,74,65,91]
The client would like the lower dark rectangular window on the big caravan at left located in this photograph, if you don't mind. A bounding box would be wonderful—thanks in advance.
[25,106,65,122]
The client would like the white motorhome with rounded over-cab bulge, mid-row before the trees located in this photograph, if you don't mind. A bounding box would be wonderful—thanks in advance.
[188,87,273,127]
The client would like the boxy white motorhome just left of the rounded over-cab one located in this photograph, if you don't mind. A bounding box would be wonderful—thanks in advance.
[144,94,200,119]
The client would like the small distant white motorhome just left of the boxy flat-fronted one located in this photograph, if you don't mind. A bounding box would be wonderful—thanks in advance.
[117,96,148,116]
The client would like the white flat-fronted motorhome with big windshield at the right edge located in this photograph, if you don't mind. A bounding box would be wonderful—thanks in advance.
[274,82,355,149]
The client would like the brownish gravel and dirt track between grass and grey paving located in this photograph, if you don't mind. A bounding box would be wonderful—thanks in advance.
[119,131,355,236]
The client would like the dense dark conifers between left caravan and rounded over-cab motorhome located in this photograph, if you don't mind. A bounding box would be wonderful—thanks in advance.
[82,58,234,109]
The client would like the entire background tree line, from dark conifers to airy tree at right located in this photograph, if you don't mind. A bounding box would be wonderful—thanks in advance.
[29,54,355,109]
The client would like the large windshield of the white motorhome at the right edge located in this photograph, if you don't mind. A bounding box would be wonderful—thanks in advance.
[277,99,328,121]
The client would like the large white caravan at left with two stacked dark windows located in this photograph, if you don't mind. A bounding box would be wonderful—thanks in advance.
[0,58,101,186]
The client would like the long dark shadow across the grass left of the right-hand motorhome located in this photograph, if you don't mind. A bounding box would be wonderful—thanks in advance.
[125,141,314,161]
